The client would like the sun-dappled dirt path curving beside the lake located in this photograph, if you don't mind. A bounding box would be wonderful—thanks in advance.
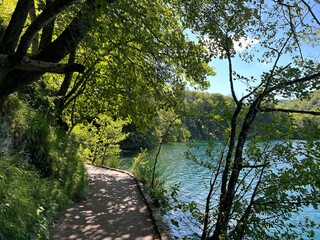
[53,165,160,240]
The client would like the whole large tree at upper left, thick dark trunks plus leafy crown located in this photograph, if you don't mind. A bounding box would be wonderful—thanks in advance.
[0,0,212,130]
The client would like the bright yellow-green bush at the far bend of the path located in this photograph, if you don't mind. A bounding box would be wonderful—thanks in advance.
[73,114,128,168]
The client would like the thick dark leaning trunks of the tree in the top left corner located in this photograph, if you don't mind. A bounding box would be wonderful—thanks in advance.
[0,0,99,99]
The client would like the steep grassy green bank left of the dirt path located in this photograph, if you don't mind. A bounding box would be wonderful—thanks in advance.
[0,95,88,239]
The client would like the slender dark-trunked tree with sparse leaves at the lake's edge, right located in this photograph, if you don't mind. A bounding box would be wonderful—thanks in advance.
[183,1,320,240]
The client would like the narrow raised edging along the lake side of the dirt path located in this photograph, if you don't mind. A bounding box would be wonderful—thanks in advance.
[91,163,172,240]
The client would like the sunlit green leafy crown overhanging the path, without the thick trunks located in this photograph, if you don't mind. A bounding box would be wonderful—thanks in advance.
[54,2,212,132]
